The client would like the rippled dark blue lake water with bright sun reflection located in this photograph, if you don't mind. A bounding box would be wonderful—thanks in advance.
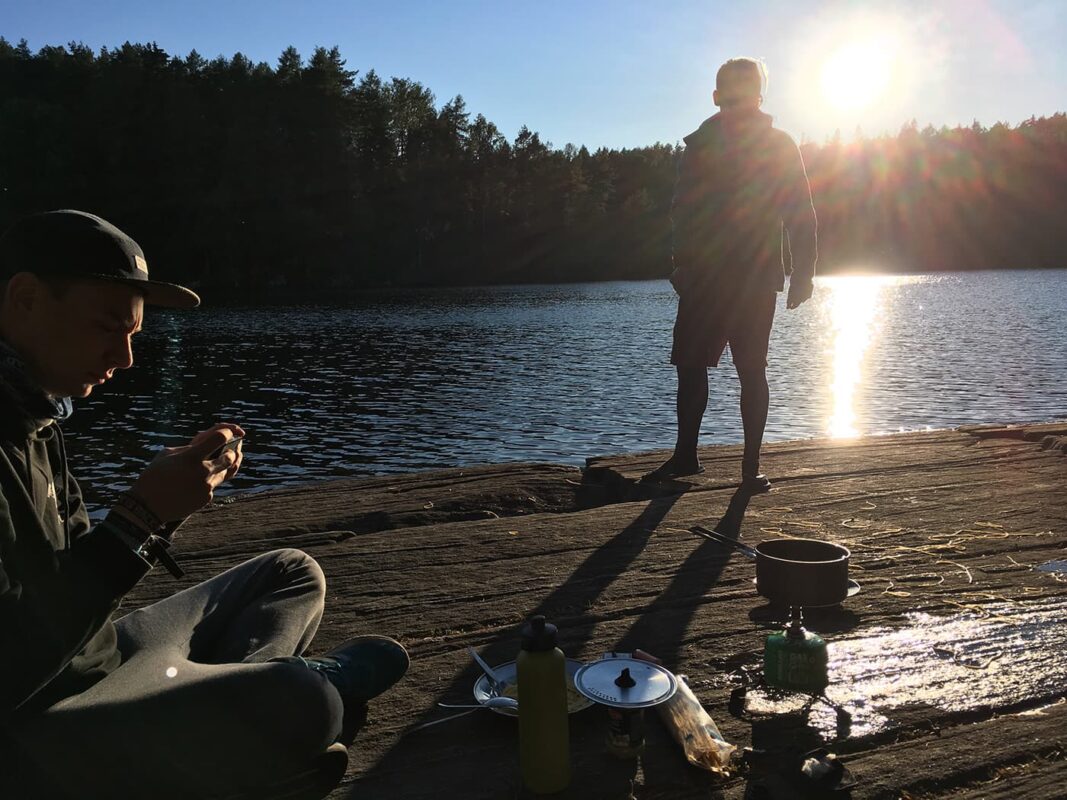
[64,271,1067,516]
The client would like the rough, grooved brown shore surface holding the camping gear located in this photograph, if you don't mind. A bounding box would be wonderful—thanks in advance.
[127,423,1067,800]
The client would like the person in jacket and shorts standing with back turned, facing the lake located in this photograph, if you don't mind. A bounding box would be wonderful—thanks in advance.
[642,59,817,492]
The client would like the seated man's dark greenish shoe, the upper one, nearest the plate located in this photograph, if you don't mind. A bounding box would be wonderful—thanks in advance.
[300,636,411,706]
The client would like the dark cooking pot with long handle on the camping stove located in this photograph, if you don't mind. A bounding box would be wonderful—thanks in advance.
[690,525,851,607]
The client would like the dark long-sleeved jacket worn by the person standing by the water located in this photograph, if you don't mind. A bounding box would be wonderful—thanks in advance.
[671,110,817,293]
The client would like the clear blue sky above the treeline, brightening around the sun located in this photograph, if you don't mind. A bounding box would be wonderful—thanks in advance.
[0,0,1067,148]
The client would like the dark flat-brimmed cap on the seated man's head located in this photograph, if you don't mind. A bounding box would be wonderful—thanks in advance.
[0,209,200,308]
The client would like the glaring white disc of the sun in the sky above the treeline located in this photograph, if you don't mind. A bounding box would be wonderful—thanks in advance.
[822,38,896,111]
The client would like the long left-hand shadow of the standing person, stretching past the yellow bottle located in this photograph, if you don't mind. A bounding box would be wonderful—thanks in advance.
[348,495,680,800]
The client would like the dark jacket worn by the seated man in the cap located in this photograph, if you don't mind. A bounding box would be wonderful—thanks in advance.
[0,386,150,722]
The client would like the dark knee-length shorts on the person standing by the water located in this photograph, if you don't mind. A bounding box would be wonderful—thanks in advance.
[670,291,778,369]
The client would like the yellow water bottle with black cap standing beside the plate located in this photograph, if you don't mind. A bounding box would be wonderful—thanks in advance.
[517,614,571,795]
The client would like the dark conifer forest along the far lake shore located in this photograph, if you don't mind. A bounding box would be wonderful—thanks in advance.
[0,37,1067,300]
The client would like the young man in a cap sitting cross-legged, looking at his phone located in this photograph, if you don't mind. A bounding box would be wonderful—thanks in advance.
[0,211,408,798]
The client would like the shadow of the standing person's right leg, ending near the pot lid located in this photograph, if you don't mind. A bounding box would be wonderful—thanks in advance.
[619,489,752,667]
